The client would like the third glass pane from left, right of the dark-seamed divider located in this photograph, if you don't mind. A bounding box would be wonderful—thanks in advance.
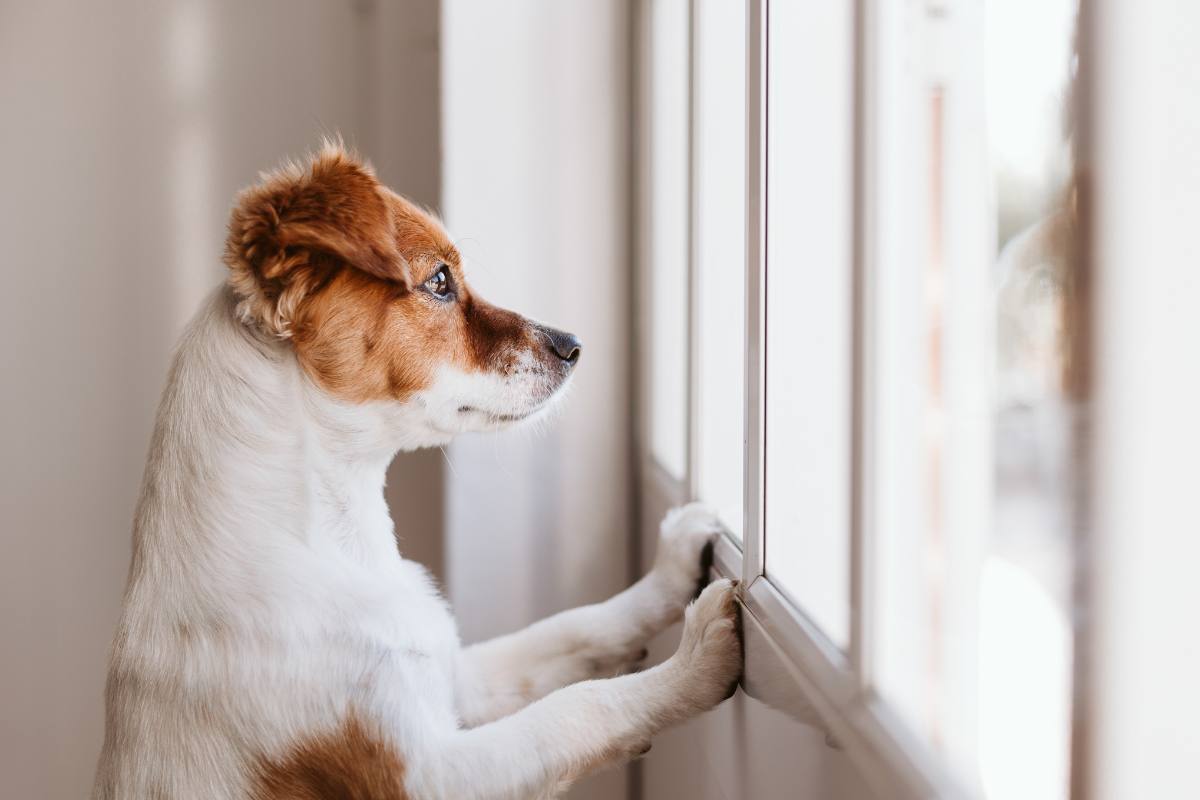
[764,2,854,646]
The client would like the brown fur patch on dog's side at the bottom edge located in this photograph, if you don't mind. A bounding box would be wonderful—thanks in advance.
[250,714,408,800]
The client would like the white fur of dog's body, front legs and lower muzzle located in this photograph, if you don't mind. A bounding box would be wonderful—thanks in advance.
[94,289,740,800]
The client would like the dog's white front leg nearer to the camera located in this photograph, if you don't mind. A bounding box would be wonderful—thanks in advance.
[417,581,742,800]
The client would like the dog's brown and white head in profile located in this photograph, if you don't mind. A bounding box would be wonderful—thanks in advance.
[226,145,580,444]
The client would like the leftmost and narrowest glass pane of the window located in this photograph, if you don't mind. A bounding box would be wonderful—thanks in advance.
[649,0,690,479]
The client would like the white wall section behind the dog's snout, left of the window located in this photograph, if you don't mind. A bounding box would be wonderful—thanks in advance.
[442,0,631,800]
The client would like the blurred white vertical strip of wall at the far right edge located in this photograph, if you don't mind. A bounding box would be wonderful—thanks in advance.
[1094,0,1200,800]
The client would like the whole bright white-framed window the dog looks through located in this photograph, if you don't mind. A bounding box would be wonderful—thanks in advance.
[647,0,1081,798]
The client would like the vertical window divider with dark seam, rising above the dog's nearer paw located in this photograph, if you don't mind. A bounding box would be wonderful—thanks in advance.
[742,0,768,587]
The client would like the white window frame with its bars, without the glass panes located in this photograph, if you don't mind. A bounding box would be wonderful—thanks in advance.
[637,0,1089,799]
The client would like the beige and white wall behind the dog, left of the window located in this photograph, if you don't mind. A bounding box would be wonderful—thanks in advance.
[0,0,632,799]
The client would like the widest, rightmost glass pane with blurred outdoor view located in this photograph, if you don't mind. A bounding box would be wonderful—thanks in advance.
[870,0,1078,798]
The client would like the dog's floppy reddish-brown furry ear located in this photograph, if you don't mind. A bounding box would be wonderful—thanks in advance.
[224,143,410,336]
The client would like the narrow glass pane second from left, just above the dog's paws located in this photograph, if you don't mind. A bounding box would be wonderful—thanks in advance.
[695,0,746,536]
